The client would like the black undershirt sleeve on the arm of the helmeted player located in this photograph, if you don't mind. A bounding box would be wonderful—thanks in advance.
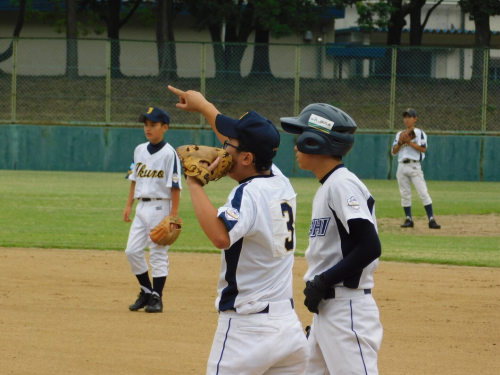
[321,219,382,286]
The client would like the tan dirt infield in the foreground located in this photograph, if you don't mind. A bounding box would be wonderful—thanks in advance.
[0,248,500,375]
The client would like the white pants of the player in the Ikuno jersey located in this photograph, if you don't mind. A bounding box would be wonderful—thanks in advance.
[125,199,172,277]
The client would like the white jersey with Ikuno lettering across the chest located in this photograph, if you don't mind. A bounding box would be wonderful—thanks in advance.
[129,142,182,199]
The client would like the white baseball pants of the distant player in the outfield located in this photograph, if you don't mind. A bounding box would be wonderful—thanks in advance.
[396,162,432,207]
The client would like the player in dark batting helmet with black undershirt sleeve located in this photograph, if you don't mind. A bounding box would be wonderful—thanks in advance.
[281,104,382,375]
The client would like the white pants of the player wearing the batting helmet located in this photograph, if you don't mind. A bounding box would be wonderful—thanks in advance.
[305,287,383,375]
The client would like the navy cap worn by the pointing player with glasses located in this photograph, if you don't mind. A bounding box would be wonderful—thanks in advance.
[215,111,280,162]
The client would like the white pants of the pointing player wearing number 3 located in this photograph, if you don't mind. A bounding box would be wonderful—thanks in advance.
[207,300,309,375]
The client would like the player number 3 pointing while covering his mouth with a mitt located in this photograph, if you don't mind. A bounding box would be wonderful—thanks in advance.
[169,86,308,375]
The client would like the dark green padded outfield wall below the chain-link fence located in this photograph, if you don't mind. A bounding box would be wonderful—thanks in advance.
[0,125,500,181]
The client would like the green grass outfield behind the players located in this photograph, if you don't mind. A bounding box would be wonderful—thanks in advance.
[0,170,500,267]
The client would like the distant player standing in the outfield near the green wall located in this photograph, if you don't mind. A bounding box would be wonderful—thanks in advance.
[392,108,441,229]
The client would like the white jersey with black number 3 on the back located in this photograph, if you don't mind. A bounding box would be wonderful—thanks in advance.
[215,165,296,314]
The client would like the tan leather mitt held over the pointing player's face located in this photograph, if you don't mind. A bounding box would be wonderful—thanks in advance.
[177,145,233,185]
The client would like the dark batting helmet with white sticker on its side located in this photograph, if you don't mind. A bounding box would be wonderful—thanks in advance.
[280,103,357,156]
